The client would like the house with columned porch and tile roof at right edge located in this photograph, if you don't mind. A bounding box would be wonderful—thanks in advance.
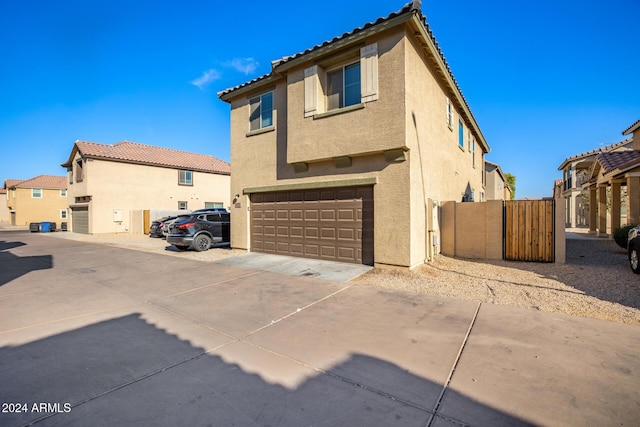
[584,120,640,235]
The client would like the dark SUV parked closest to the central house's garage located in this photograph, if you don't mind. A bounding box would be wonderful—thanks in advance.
[167,212,230,252]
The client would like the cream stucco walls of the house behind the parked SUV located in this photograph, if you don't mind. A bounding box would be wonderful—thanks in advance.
[68,154,231,234]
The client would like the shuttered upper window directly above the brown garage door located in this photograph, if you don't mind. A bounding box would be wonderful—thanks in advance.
[304,43,378,117]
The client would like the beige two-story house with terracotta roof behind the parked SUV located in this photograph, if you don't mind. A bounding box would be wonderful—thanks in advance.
[62,141,230,234]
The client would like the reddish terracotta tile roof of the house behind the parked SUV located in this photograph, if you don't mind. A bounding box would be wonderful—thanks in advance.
[71,141,231,175]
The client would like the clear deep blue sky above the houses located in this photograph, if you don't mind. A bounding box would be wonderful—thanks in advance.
[0,0,640,198]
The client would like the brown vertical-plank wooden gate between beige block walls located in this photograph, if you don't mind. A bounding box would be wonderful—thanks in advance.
[502,200,555,262]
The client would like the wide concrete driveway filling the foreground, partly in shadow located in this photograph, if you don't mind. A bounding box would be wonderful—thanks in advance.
[0,232,640,426]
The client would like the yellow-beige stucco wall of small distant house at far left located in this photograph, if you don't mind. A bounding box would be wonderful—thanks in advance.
[7,188,67,227]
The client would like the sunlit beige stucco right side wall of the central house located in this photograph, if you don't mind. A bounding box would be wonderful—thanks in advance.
[403,33,484,266]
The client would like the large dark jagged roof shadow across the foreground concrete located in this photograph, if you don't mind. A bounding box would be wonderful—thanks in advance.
[0,314,527,426]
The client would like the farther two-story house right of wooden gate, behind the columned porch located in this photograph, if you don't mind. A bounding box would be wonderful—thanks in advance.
[558,138,632,227]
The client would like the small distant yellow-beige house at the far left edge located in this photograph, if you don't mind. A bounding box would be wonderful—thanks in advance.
[4,175,68,227]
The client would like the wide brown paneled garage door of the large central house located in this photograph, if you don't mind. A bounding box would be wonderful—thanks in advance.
[251,187,373,265]
